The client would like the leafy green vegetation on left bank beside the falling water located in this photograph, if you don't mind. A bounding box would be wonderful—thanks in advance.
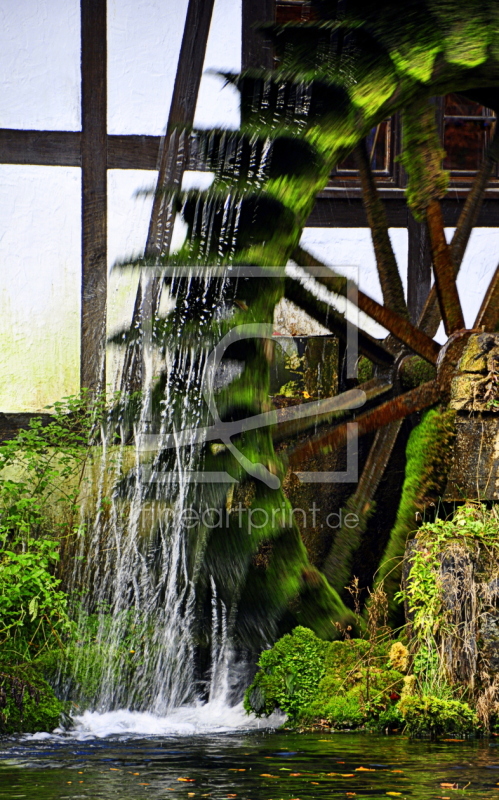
[0,393,108,732]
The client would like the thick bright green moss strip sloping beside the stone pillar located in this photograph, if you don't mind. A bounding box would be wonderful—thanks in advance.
[376,408,455,621]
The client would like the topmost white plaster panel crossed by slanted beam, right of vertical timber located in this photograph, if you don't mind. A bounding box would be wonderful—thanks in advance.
[109,0,241,136]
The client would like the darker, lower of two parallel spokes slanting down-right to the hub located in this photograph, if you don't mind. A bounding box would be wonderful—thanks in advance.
[285,277,394,367]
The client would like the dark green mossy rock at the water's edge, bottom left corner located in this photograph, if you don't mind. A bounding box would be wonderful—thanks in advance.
[0,663,68,734]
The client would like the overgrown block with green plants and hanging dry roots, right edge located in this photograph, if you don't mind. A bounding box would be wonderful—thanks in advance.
[397,504,499,712]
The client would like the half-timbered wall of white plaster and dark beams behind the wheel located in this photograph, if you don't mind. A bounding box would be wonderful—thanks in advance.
[0,0,499,413]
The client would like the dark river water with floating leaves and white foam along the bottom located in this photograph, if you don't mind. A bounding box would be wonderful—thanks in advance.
[0,706,499,800]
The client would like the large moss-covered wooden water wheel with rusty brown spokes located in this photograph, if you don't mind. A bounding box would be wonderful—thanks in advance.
[116,0,499,643]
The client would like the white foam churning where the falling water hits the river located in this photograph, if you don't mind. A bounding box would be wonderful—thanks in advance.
[69,702,284,739]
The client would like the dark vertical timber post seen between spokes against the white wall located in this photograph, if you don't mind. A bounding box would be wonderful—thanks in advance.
[407,214,431,325]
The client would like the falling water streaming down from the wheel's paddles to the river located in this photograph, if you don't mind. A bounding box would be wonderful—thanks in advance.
[54,87,296,727]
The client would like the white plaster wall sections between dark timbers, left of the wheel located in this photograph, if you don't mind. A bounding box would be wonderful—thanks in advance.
[0,0,241,411]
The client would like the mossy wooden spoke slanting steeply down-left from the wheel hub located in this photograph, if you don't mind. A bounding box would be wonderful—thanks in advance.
[322,420,402,592]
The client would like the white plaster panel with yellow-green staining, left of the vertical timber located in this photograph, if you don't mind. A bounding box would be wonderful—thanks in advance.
[0,164,81,411]
